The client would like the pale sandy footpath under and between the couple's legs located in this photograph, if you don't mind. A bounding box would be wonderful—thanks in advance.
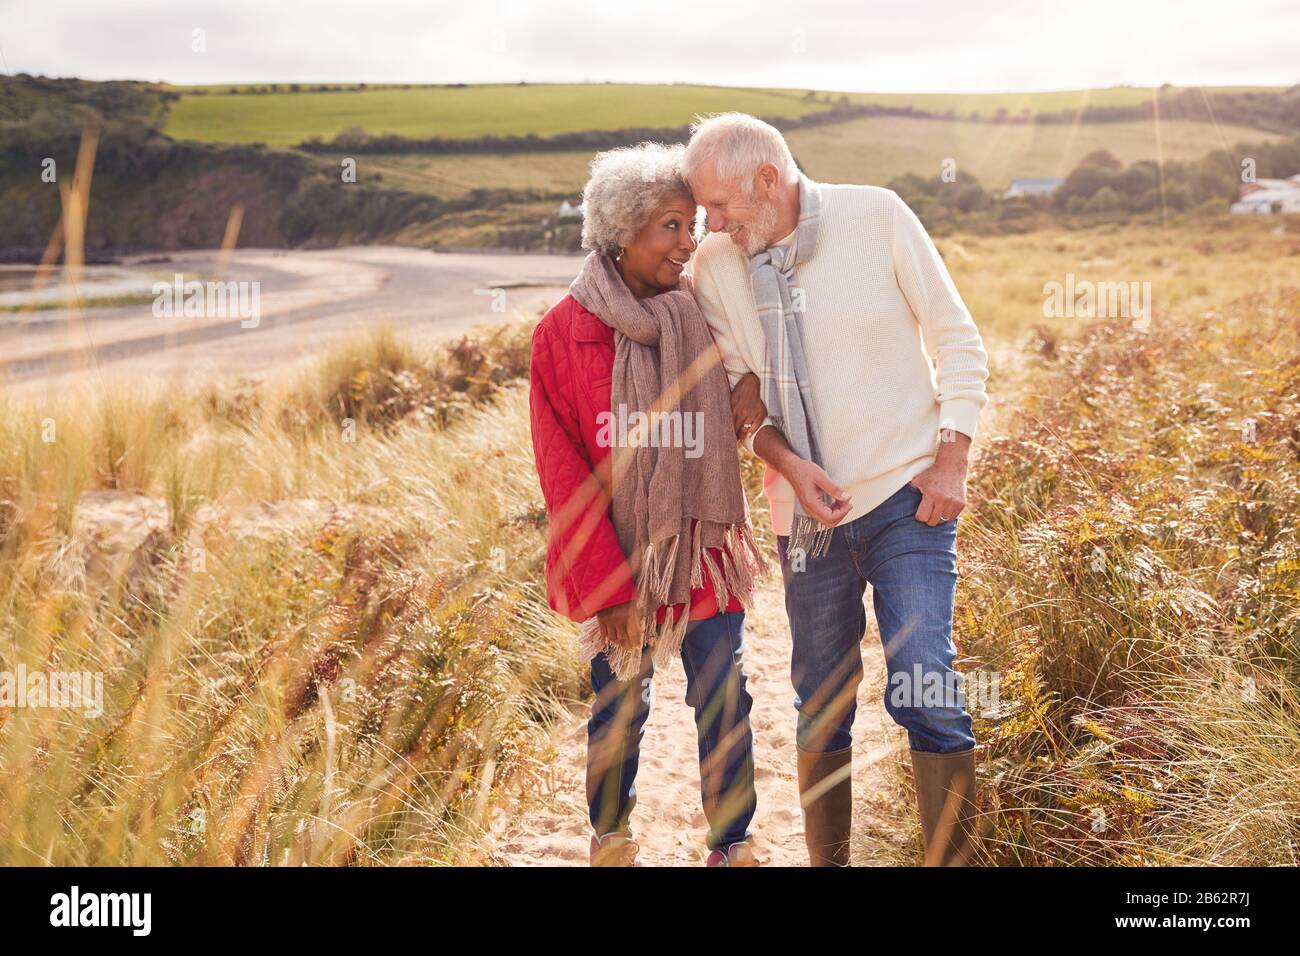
[493,572,915,866]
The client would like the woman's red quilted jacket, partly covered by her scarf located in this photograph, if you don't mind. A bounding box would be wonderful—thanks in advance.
[529,295,742,629]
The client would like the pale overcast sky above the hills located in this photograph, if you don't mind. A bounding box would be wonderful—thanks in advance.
[0,0,1300,92]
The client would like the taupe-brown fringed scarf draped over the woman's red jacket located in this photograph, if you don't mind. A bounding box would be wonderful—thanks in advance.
[569,252,767,680]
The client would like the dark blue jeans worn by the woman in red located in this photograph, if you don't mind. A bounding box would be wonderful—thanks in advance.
[586,611,757,851]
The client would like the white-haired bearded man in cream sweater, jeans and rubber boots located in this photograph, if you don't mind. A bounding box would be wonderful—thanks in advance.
[684,113,988,866]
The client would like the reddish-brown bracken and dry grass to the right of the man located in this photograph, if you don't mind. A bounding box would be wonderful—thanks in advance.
[956,286,1300,865]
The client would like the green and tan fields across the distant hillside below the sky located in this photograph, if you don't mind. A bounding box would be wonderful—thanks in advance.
[165,85,1300,205]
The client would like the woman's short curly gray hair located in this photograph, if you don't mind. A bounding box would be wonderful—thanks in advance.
[582,142,690,255]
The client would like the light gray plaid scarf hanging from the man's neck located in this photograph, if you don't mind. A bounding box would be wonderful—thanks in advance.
[749,173,833,558]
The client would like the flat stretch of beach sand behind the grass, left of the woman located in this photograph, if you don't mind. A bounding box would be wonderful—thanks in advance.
[0,246,582,394]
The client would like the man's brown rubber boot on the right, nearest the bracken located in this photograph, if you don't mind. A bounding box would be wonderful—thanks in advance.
[911,747,979,866]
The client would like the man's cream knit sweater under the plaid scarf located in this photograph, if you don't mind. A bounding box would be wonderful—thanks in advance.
[690,183,988,535]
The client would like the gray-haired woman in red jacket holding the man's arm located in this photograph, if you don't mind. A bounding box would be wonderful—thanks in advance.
[529,143,766,866]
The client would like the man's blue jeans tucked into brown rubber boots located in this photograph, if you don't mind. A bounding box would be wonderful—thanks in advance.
[776,484,975,753]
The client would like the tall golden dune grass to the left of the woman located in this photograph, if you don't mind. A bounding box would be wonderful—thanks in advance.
[0,326,580,865]
